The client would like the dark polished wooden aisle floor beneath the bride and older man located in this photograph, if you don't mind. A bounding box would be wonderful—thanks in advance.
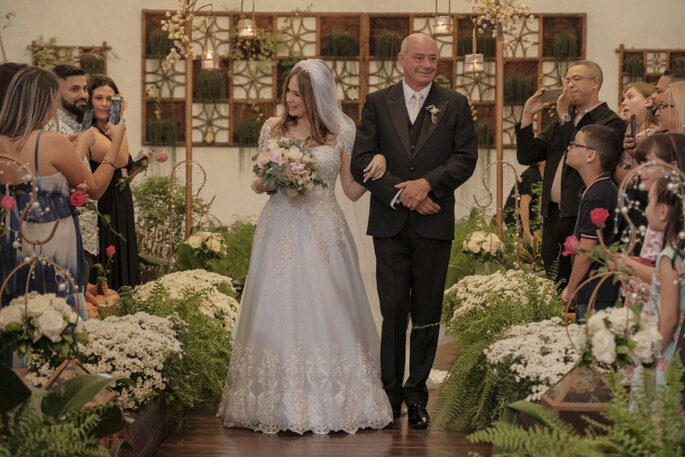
[155,339,491,457]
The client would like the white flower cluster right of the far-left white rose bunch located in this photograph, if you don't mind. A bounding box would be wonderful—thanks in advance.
[26,312,185,410]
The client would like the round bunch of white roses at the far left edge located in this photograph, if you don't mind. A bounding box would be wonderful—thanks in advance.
[0,292,88,357]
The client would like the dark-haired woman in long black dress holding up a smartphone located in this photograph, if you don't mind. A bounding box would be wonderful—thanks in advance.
[88,75,140,290]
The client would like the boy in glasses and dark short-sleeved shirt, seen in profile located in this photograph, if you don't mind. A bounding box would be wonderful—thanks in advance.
[561,125,620,322]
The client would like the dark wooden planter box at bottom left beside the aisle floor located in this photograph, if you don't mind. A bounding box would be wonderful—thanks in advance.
[102,396,174,457]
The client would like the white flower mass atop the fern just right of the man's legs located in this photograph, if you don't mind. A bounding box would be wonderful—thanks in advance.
[445,270,557,321]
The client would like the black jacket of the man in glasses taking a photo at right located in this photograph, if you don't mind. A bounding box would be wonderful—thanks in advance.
[516,103,626,217]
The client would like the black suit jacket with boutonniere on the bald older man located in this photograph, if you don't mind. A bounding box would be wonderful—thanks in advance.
[351,81,478,240]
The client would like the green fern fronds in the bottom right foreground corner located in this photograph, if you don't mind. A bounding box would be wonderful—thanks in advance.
[468,354,685,457]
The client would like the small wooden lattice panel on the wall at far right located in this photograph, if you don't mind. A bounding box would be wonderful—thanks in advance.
[616,44,685,102]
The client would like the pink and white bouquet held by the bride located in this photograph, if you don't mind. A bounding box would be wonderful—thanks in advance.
[252,136,327,197]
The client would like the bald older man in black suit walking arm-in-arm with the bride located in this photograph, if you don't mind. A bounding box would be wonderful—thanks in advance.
[351,33,478,428]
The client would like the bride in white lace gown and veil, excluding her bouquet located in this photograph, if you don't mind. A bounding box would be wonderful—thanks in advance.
[218,59,392,434]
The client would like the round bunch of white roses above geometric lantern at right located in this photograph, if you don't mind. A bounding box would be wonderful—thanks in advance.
[581,308,662,368]
